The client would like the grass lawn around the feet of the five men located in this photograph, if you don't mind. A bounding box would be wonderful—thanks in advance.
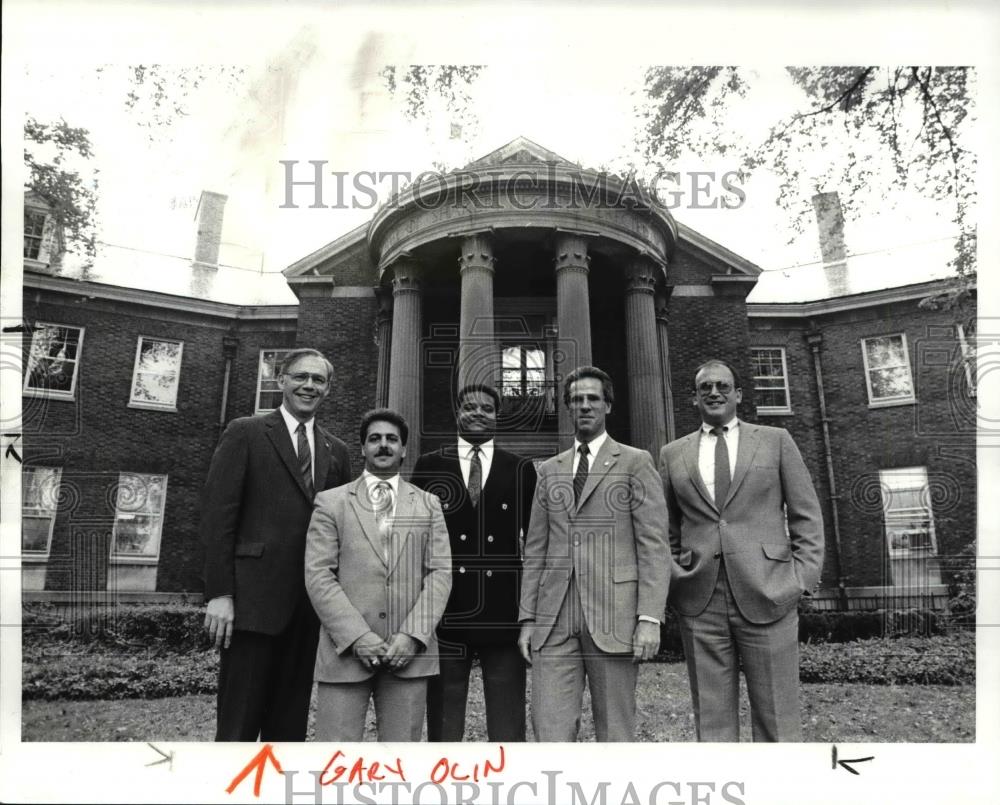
[21,663,976,743]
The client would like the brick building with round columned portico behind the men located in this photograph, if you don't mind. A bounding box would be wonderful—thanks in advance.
[22,139,976,607]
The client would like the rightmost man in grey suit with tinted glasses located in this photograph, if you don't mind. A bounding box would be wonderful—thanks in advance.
[660,360,823,741]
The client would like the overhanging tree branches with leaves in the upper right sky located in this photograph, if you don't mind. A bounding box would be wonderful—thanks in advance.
[638,66,976,310]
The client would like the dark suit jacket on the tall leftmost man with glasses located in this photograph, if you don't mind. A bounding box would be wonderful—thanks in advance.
[201,411,351,634]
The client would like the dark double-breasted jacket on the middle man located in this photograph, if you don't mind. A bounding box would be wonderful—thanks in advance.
[412,444,535,645]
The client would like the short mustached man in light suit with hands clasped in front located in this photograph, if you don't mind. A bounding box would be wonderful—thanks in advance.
[305,408,451,741]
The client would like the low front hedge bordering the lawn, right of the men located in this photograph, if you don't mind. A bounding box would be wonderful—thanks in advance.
[799,632,976,685]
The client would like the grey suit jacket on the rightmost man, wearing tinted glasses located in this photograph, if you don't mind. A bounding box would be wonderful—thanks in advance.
[660,420,823,623]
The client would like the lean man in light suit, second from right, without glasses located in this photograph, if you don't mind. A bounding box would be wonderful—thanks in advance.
[518,366,670,741]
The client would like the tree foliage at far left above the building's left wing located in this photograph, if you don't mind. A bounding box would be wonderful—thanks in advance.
[24,117,98,264]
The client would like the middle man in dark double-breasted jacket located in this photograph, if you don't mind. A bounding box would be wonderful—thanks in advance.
[413,385,535,741]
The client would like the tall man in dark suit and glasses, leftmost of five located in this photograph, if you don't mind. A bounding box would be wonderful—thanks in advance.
[201,349,351,741]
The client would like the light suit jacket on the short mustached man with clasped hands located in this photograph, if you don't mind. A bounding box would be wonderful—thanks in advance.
[305,477,451,682]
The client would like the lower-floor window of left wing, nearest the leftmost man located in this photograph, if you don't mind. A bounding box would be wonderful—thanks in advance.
[111,472,167,563]
